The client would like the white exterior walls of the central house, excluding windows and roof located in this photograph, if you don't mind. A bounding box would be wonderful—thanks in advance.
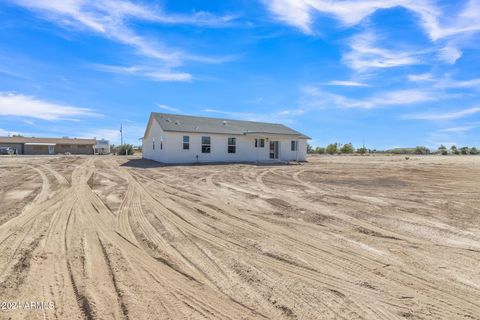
[143,128,307,163]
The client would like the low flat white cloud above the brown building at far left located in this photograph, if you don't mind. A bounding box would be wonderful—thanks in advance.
[0,93,98,121]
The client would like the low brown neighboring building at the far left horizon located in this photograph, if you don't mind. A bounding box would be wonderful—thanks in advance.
[0,137,96,155]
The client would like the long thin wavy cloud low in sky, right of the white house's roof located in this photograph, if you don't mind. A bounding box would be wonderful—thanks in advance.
[303,86,442,109]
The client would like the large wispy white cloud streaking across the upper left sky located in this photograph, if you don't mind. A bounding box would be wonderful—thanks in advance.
[11,0,233,69]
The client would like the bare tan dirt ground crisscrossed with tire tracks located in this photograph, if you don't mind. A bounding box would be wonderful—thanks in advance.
[0,156,480,319]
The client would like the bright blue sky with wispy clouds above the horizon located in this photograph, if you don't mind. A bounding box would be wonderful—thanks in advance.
[0,0,480,149]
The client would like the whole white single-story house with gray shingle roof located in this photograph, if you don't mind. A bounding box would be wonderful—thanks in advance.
[143,112,310,163]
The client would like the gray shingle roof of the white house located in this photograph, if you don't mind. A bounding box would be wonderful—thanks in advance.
[152,112,310,139]
